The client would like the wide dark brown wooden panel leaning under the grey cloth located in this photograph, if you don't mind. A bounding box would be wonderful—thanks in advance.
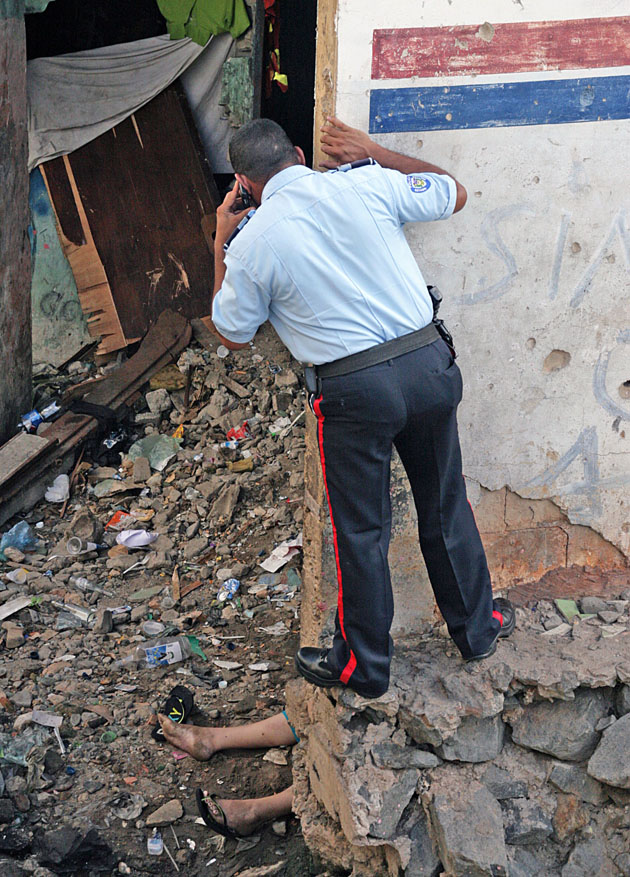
[70,87,218,342]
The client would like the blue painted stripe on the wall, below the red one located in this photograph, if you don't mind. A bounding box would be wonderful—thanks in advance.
[370,76,630,134]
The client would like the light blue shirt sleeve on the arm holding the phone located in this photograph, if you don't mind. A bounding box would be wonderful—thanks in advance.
[212,256,271,344]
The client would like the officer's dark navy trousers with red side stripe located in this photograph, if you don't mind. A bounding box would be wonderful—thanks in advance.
[312,339,499,695]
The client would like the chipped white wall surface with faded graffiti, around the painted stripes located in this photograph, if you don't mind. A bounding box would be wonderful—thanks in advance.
[336,0,630,554]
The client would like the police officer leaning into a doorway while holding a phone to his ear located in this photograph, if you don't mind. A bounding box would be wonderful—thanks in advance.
[212,118,515,697]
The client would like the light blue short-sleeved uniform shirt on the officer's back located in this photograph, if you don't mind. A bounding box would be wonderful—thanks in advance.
[212,165,457,365]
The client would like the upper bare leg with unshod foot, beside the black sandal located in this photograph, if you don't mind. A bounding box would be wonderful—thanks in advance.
[158,713,295,756]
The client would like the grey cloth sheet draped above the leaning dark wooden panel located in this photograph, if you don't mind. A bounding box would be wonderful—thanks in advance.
[27,34,233,173]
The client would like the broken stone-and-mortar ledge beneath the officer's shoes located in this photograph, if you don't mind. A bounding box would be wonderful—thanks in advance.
[287,604,630,877]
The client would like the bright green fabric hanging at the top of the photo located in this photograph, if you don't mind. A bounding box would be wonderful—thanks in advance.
[157,0,250,46]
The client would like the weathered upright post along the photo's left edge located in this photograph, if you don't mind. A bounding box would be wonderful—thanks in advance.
[0,0,31,444]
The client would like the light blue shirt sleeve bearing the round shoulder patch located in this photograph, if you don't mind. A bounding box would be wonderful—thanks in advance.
[384,169,457,223]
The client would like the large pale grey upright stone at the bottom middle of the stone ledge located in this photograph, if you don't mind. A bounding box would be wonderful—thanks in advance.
[428,774,507,877]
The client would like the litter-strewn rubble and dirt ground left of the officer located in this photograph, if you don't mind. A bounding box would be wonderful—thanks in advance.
[0,327,319,877]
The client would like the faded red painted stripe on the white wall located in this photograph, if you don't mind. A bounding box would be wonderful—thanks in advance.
[372,16,630,79]
